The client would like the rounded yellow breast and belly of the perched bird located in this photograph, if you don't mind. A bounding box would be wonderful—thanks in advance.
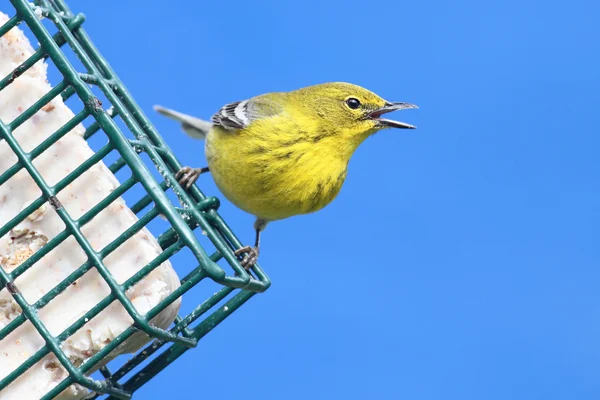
[205,113,351,221]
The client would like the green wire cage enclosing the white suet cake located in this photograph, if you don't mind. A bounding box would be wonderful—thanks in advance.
[0,0,270,399]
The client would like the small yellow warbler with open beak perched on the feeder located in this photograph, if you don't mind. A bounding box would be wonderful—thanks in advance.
[154,82,417,269]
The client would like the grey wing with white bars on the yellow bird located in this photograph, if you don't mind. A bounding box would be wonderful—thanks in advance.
[212,93,284,131]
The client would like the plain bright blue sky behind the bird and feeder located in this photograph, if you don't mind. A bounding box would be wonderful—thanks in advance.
[3,0,600,400]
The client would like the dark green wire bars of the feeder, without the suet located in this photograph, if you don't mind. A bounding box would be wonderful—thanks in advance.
[0,0,270,399]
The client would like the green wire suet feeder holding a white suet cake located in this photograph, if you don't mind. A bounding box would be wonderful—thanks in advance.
[0,0,270,399]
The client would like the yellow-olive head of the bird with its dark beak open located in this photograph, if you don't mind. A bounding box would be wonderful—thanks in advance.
[292,82,417,141]
